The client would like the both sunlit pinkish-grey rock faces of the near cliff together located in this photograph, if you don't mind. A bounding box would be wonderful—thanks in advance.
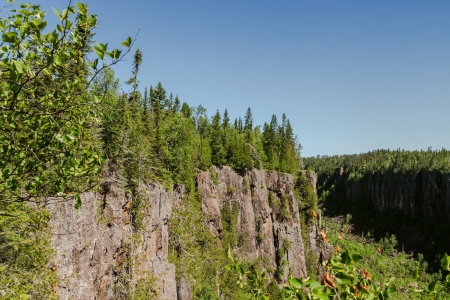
[49,167,313,299]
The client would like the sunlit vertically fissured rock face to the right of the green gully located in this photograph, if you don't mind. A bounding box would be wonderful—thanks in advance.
[197,167,307,281]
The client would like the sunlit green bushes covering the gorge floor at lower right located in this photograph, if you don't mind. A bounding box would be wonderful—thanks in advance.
[226,207,450,299]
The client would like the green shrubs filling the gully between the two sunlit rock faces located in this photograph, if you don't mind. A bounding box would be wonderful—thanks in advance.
[169,194,246,299]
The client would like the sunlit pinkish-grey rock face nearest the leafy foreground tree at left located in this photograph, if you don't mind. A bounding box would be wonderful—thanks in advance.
[49,182,183,300]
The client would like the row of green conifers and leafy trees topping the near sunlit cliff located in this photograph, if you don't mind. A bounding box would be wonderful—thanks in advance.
[95,50,301,195]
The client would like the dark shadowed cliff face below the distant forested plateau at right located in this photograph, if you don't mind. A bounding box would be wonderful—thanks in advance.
[344,171,450,223]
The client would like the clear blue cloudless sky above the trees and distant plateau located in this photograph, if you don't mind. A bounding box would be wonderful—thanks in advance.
[40,0,450,157]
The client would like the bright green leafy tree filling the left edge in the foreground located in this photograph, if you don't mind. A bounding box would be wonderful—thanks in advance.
[0,3,131,299]
